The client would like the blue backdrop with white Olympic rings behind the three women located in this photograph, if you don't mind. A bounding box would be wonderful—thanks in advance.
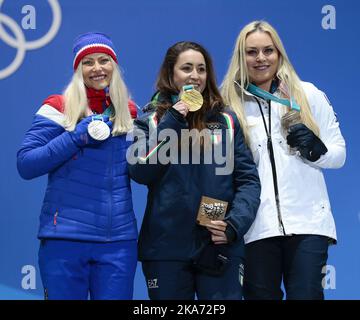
[0,0,360,299]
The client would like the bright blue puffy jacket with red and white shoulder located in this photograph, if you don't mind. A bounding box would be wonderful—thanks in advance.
[17,96,137,242]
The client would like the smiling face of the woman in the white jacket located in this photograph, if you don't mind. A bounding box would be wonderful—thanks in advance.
[245,31,279,91]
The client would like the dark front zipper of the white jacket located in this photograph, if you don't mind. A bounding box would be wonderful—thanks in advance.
[255,98,286,235]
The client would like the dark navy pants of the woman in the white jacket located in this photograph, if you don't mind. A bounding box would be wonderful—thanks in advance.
[244,235,328,300]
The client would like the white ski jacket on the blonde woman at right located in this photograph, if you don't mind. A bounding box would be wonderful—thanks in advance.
[244,82,346,243]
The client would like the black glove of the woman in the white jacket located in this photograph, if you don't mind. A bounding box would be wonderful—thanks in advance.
[286,123,328,162]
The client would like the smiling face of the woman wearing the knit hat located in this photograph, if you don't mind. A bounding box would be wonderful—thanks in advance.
[82,53,114,90]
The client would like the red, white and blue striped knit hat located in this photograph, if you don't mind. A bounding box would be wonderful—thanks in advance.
[73,32,118,70]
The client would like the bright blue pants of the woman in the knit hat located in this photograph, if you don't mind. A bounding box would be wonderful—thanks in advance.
[39,239,137,300]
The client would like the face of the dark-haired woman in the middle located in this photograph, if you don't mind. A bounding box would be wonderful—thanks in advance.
[173,49,207,92]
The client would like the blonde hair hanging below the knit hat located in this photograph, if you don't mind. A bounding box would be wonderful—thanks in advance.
[63,56,133,136]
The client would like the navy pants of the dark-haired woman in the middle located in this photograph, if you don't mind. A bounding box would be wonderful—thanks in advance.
[142,258,243,300]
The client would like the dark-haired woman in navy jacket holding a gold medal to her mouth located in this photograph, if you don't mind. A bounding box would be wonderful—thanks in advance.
[128,42,260,300]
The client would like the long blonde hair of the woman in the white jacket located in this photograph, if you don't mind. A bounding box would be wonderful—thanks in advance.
[221,21,319,143]
